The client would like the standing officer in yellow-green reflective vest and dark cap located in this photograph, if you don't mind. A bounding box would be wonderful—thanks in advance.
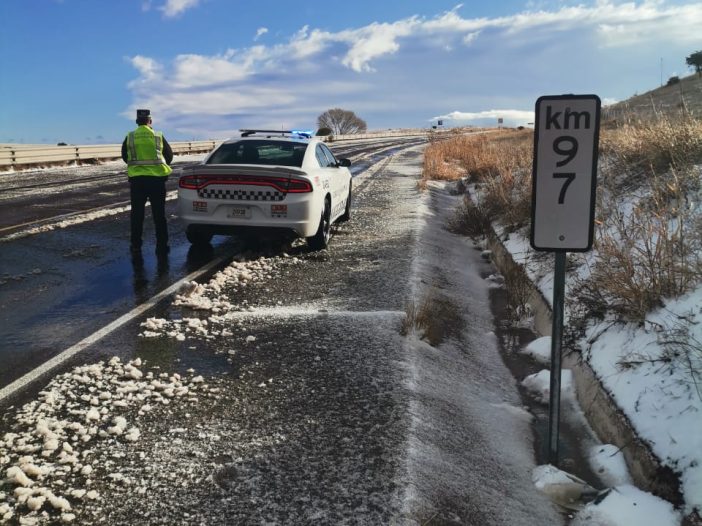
[122,110,173,256]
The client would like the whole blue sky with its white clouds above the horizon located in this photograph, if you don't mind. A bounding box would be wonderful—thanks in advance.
[0,0,702,144]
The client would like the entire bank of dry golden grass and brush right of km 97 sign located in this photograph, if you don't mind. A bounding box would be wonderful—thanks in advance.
[580,115,702,321]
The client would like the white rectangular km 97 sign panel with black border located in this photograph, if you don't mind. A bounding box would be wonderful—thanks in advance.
[531,95,600,252]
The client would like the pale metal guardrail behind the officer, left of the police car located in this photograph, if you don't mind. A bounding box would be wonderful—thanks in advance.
[0,141,220,170]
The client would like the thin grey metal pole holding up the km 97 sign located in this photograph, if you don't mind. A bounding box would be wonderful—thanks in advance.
[548,252,566,466]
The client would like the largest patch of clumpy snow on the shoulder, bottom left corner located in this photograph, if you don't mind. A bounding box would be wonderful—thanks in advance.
[0,357,214,524]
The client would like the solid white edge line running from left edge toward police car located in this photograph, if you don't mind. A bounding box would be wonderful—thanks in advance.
[0,256,227,402]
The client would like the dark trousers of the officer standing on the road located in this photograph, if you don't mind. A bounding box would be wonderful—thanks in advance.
[129,175,168,249]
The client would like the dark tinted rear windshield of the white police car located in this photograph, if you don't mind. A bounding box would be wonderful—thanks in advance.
[207,139,307,168]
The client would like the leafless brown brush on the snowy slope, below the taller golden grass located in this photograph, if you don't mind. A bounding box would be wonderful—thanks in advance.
[582,169,702,321]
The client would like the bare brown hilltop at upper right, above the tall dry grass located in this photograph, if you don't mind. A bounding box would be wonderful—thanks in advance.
[602,73,702,121]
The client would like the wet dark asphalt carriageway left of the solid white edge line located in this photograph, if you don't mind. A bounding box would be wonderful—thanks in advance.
[0,139,421,394]
